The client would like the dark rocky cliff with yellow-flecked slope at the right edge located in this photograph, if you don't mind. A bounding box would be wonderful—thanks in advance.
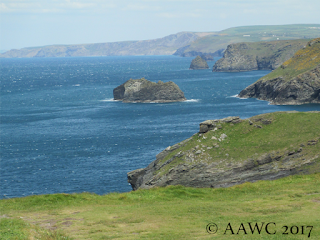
[239,38,320,105]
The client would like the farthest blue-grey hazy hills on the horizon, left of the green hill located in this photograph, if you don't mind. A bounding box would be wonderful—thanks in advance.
[0,32,210,58]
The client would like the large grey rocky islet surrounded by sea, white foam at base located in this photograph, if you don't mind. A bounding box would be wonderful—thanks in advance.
[113,78,186,103]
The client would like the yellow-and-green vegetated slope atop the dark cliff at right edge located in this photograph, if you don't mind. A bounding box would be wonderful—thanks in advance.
[261,38,320,81]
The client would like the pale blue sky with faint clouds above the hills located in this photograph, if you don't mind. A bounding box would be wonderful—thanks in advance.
[0,0,320,50]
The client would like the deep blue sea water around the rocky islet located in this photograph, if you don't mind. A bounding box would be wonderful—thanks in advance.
[0,56,320,198]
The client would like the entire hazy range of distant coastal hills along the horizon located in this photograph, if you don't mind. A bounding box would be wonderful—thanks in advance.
[0,24,320,58]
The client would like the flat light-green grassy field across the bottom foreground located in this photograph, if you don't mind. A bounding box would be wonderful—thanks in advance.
[0,173,320,240]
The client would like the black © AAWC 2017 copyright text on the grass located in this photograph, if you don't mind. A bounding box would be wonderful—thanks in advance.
[206,222,313,238]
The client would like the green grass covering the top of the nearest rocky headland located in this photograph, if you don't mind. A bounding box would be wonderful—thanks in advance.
[154,112,320,174]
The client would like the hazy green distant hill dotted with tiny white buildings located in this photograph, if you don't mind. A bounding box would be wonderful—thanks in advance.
[186,24,320,52]
